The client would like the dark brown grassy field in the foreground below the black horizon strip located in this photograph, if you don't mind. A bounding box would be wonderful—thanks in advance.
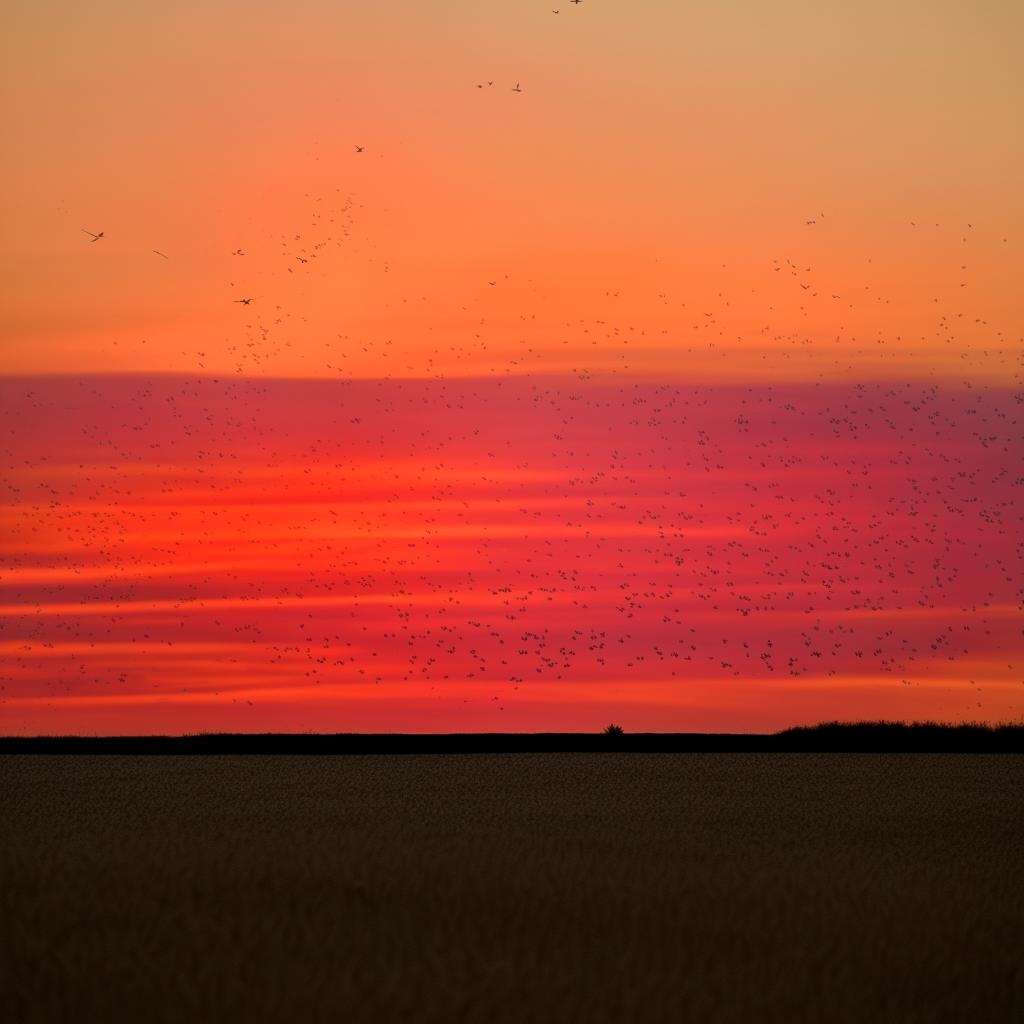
[0,753,1024,1024]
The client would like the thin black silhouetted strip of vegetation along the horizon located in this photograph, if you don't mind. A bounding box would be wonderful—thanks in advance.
[0,722,1024,755]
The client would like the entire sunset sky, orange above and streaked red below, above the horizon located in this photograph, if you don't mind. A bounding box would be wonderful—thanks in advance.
[0,0,1024,732]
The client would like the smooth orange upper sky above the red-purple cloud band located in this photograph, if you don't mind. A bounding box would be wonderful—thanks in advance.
[0,0,1024,380]
